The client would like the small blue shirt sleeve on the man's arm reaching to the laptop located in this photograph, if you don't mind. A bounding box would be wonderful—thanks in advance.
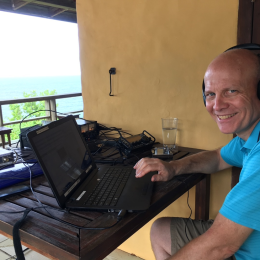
[220,137,243,168]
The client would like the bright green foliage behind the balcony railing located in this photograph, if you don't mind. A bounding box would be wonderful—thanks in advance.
[8,90,58,140]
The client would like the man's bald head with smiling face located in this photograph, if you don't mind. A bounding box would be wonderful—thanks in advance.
[204,49,260,140]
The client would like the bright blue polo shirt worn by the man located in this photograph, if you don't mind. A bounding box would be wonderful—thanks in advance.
[219,122,260,260]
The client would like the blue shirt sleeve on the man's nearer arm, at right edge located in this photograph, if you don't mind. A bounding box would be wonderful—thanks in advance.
[219,145,260,231]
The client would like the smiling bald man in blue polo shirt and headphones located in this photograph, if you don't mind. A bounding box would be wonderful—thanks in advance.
[134,49,260,260]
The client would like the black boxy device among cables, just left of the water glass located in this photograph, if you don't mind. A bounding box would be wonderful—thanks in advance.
[117,130,155,156]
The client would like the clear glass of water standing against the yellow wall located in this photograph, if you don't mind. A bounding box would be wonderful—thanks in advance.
[162,118,178,154]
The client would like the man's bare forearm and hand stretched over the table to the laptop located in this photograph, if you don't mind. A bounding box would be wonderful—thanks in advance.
[134,149,231,181]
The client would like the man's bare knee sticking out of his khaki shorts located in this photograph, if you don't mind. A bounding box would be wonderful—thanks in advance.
[150,218,172,260]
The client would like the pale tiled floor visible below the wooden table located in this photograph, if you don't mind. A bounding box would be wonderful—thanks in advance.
[0,234,143,260]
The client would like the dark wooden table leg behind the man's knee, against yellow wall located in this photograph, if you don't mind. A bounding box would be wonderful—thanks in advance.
[195,174,210,220]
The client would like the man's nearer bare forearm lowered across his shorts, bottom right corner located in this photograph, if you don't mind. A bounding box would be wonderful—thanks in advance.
[167,213,253,260]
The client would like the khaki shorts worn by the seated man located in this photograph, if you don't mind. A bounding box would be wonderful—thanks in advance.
[171,218,236,260]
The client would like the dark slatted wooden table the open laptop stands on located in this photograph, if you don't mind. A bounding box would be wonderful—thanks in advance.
[0,147,209,260]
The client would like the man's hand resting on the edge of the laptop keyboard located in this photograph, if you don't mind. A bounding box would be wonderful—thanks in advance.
[134,158,176,181]
